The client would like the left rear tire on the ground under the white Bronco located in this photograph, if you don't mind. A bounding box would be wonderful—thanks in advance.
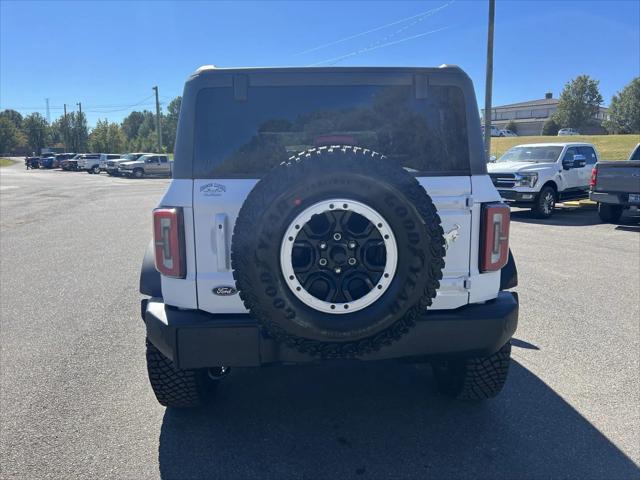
[147,340,218,408]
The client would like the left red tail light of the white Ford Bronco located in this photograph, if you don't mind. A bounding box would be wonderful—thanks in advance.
[153,208,186,278]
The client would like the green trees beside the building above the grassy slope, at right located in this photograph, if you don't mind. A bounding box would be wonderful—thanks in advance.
[505,75,640,135]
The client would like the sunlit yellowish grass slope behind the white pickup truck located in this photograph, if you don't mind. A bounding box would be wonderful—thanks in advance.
[491,134,640,160]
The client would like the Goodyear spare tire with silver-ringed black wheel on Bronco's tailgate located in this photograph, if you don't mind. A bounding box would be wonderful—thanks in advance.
[231,146,445,358]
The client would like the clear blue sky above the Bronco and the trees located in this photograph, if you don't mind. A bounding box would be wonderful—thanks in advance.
[0,0,640,125]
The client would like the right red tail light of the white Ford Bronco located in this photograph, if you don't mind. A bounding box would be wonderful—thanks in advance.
[480,203,510,272]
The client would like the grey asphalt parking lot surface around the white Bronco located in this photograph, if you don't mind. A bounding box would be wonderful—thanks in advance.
[0,165,640,479]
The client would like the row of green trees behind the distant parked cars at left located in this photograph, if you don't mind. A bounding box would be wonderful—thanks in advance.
[0,97,182,155]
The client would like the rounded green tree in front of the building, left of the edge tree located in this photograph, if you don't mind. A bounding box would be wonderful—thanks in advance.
[554,75,602,128]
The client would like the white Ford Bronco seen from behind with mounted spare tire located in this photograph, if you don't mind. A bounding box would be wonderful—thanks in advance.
[140,66,518,407]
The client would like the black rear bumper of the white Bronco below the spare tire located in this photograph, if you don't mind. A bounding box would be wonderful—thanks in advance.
[141,292,518,369]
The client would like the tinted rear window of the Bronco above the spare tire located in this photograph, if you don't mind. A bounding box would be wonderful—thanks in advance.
[194,85,469,178]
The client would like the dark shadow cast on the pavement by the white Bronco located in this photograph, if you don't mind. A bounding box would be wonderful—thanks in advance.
[159,362,638,479]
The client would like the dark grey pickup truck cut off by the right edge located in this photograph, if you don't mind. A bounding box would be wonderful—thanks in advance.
[589,143,640,223]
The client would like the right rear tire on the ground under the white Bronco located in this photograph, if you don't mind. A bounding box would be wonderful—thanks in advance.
[432,342,511,400]
